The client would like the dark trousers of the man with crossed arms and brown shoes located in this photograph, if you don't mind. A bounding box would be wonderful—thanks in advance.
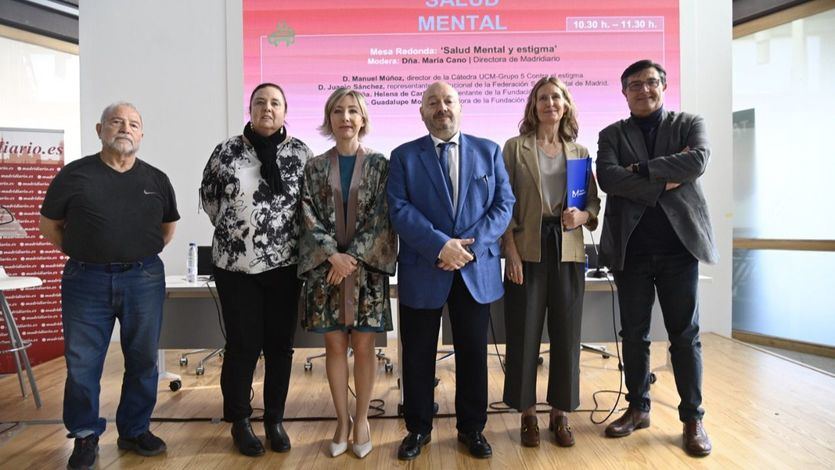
[614,253,704,421]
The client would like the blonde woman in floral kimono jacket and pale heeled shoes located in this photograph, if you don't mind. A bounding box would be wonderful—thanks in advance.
[299,88,397,458]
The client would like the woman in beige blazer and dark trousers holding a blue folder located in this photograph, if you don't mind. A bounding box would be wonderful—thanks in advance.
[503,77,600,447]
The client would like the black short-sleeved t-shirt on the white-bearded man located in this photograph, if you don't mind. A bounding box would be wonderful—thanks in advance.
[41,154,180,263]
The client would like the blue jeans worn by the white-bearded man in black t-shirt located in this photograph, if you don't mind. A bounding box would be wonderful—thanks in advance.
[61,256,165,437]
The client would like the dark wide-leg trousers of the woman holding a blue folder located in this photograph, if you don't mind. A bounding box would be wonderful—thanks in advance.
[503,226,586,411]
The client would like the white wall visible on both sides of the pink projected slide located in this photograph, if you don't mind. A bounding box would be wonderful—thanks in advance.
[79,0,733,334]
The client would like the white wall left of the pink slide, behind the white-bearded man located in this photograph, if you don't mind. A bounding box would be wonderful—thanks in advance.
[79,0,232,274]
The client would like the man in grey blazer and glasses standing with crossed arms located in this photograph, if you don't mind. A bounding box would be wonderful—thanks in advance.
[597,60,718,456]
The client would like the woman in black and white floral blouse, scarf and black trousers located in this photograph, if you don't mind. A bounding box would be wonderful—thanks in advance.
[200,83,312,456]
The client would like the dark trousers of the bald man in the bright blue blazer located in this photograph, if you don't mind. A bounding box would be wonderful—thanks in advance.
[400,272,490,434]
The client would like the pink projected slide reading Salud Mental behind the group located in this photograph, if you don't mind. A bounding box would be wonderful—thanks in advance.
[242,0,679,156]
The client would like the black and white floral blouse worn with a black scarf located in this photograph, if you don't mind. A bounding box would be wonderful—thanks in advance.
[200,135,313,274]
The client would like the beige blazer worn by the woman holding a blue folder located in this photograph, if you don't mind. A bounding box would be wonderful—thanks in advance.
[502,133,600,263]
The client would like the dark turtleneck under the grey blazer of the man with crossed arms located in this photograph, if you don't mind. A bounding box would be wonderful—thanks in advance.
[626,107,686,257]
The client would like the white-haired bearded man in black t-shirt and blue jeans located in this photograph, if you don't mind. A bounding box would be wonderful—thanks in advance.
[40,102,180,469]
